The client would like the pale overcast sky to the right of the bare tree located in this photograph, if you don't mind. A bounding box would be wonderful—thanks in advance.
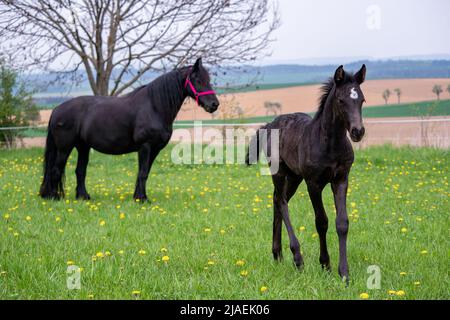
[265,0,450,62]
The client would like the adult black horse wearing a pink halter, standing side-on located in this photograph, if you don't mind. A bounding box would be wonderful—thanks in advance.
[40,58,219,200]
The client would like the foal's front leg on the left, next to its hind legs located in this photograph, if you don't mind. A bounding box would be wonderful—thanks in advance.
[308,183,331,270]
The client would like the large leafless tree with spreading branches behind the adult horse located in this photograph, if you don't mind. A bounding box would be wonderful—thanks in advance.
[0,0,279,95]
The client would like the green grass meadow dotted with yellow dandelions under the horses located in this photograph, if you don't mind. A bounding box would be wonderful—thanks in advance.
[0,146,450,299]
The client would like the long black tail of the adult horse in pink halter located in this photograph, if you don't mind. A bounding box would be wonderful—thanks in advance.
[39,122,64,199]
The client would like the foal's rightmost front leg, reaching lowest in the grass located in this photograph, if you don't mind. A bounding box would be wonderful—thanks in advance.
[331,174,349,284]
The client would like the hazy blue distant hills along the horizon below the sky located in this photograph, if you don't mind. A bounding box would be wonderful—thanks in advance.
[30,60,450,104]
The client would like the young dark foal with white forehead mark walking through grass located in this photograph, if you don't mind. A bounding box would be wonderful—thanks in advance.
[247,65,366,283]
